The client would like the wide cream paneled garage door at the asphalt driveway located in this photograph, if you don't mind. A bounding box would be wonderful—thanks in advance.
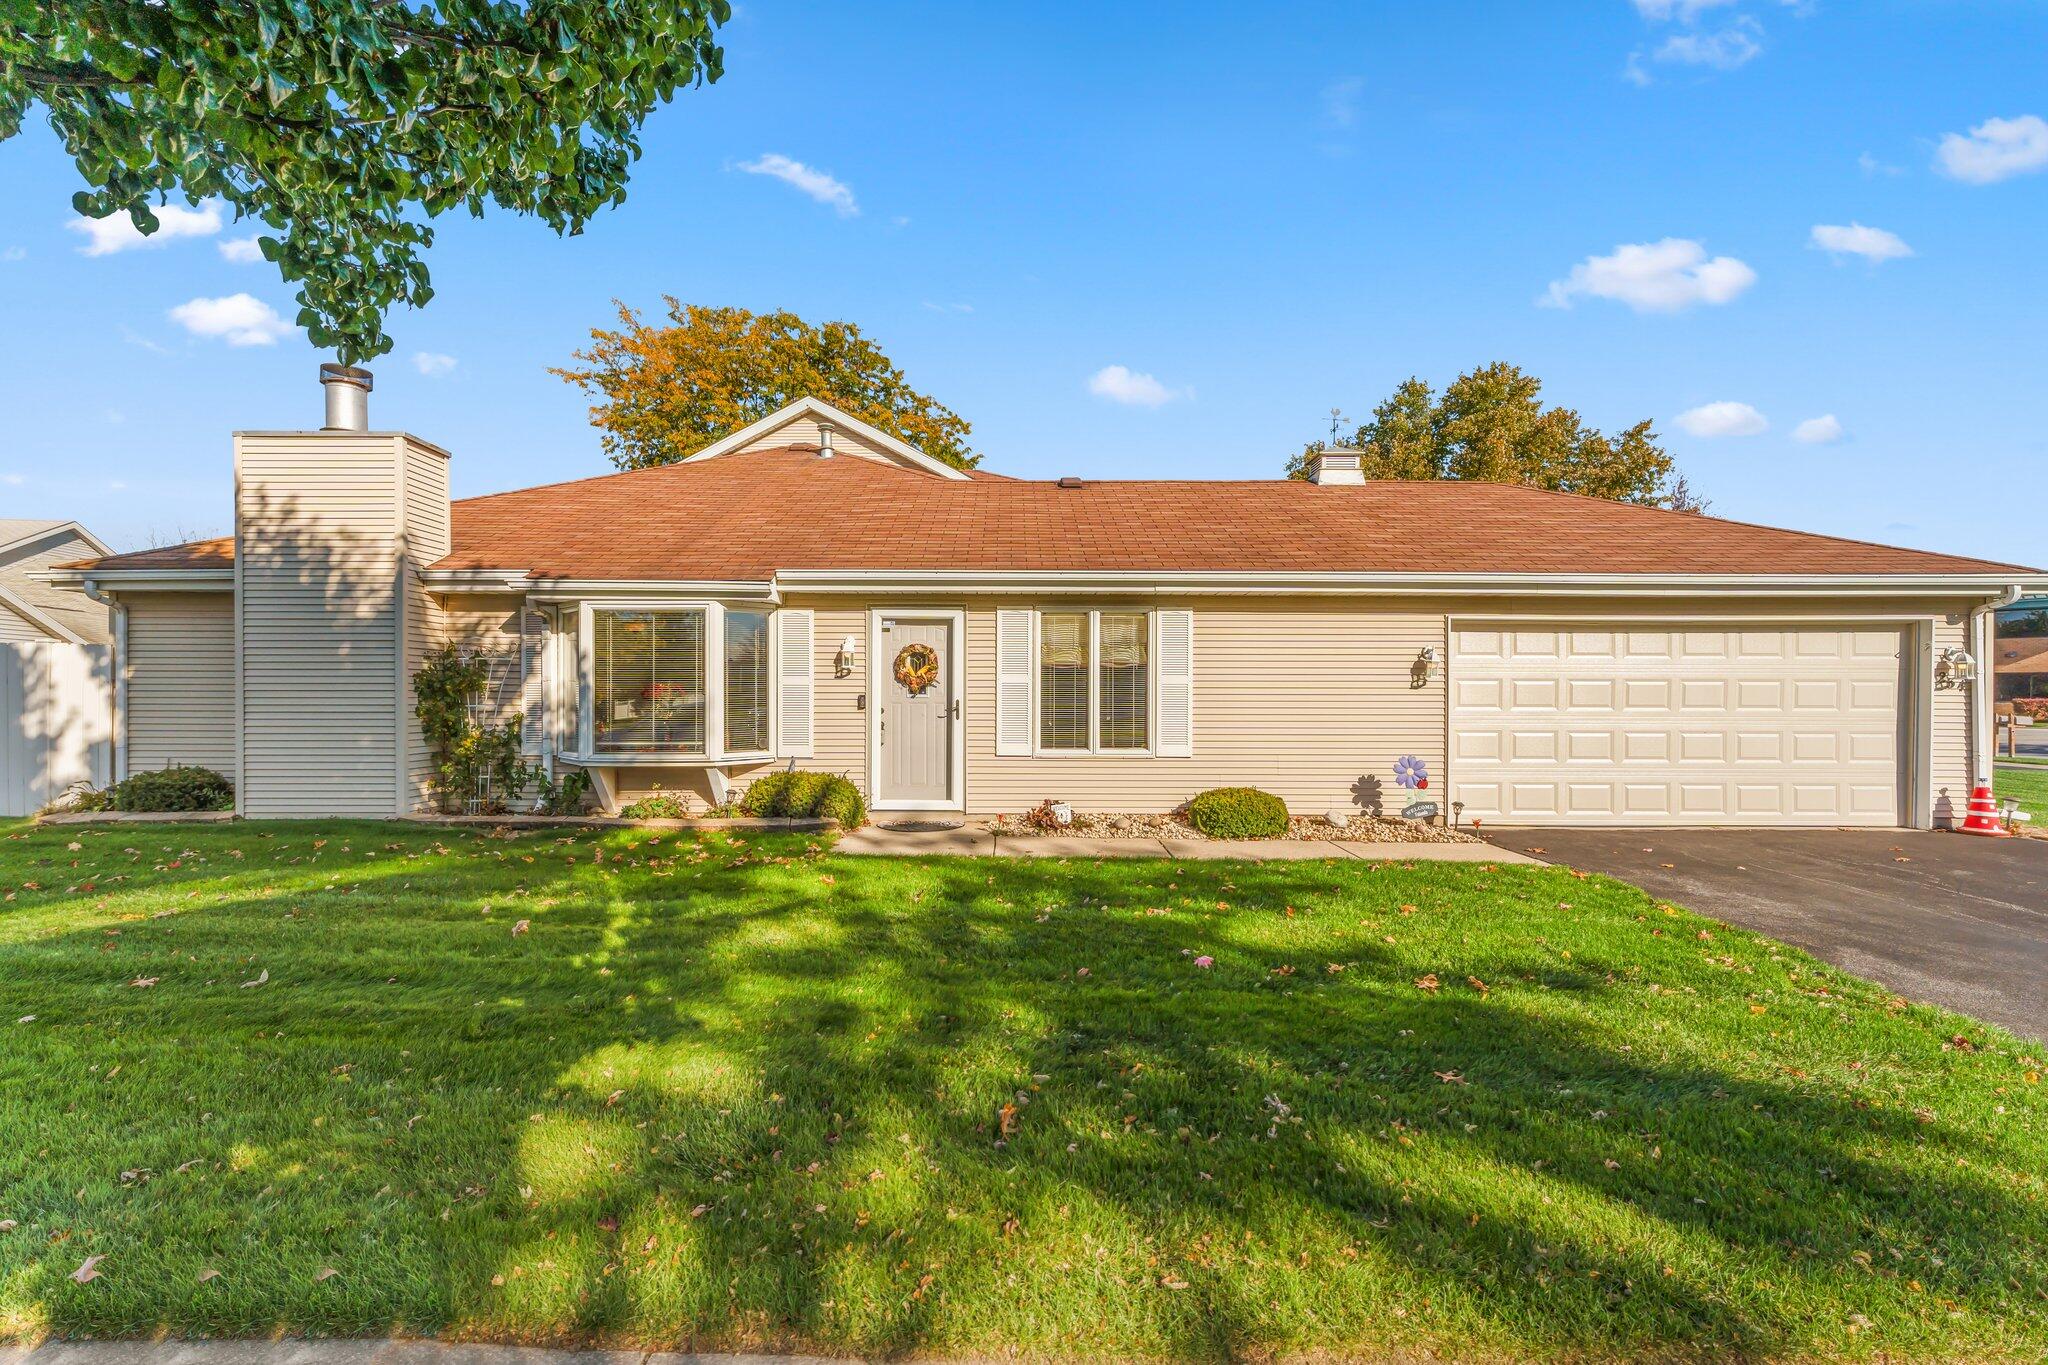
[1450,624,1903,825]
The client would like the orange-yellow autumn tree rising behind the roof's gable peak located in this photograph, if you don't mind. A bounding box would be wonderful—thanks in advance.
[555,299,981,469]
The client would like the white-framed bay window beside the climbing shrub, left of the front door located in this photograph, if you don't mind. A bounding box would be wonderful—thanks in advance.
[582,604,774,761]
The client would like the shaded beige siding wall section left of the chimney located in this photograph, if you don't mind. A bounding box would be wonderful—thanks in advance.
[123,591,236,776]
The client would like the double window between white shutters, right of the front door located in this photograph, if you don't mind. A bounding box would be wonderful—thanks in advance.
[1038,612,1151,753]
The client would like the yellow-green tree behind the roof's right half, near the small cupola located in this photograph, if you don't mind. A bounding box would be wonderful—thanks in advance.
[1288,362,1706,512]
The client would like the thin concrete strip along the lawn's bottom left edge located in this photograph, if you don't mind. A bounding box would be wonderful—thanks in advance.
[0,1338,844,1365]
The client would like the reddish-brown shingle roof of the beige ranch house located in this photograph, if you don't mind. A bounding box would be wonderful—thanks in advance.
[72,448,2034,581]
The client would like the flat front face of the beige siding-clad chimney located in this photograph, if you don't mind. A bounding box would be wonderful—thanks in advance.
[236,432,399,817]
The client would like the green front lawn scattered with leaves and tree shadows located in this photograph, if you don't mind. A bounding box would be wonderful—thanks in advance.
[0,823,2048,1359]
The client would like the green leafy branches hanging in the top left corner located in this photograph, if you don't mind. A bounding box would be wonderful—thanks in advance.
[0,0,731,364]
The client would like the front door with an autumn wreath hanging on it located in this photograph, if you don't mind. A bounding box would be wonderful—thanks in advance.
[870,612,961,810]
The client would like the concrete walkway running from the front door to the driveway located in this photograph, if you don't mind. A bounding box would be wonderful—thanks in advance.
[831,823,1542,864]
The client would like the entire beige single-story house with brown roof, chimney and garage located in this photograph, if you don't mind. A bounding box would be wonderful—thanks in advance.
[44,366,2048,827]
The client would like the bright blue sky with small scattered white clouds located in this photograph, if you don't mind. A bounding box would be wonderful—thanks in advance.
[0,0,2048,565]
